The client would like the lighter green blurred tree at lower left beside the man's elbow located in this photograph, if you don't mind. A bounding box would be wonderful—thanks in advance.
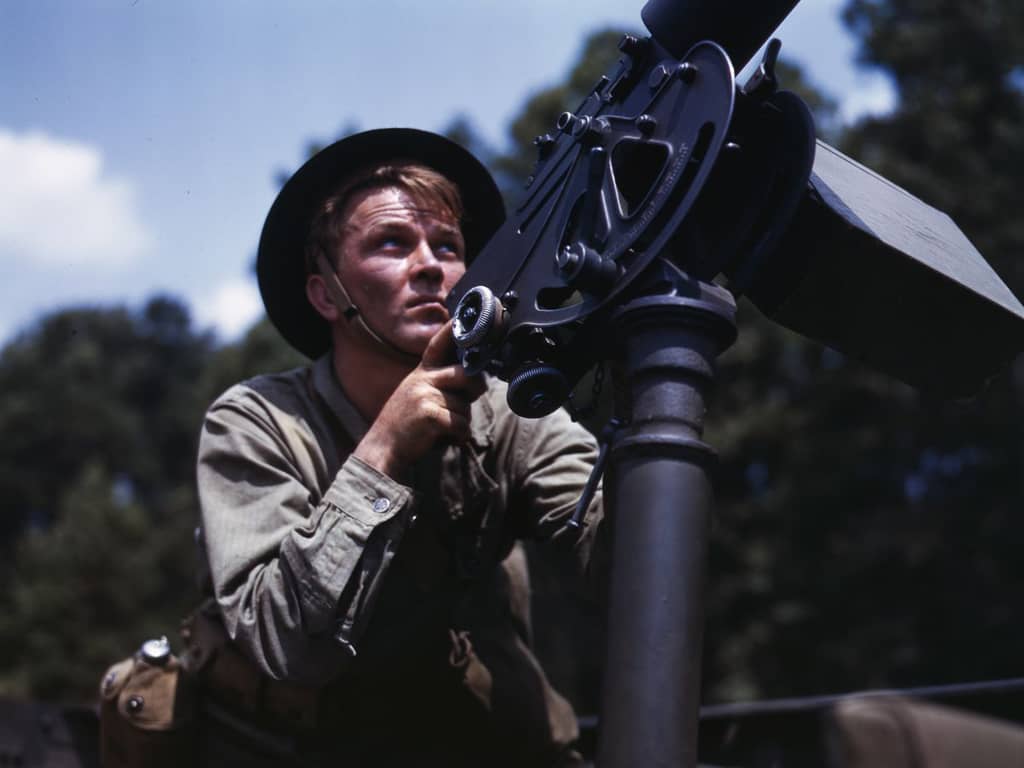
[0,462,196,701]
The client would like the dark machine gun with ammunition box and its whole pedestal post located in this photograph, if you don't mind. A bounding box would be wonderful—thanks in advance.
[449,0,1024,768]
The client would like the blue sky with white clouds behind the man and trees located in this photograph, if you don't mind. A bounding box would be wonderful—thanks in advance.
[0,0,892,343]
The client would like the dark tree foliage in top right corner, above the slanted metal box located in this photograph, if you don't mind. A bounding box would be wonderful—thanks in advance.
[844,0,1024,294]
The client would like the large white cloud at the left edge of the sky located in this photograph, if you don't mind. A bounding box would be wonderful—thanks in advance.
[0,129,152,266]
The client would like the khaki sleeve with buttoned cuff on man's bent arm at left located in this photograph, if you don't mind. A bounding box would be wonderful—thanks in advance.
[198,385,415,682]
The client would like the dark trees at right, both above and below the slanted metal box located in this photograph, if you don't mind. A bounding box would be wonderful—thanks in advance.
[708,0,1024,698]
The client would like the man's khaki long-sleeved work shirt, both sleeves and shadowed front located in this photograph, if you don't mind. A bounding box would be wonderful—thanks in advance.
[198,355,601,765]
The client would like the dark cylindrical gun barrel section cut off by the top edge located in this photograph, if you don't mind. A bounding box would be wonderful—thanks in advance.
[640,0,800,71]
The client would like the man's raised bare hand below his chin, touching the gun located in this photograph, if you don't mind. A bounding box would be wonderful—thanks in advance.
[353,322,486,478]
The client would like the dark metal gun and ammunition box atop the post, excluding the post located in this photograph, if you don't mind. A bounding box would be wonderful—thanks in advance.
[449,0,1024,417]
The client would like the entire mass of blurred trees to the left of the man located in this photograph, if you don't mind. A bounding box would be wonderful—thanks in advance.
[0,297,298,700]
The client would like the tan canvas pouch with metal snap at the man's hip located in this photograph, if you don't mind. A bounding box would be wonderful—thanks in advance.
[99,652,198,768]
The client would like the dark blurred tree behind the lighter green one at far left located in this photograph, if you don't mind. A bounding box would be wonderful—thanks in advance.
[0,298,211,541]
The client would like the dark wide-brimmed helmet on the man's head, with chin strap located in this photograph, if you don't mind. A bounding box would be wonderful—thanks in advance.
[256,128,505,357]
